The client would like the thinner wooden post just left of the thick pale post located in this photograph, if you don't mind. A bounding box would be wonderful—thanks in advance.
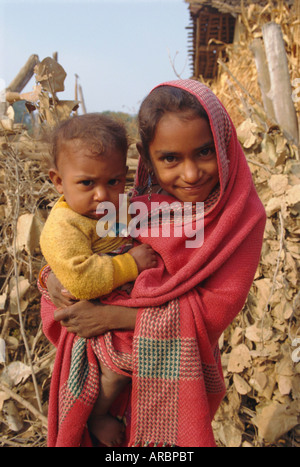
[250,39,275,120]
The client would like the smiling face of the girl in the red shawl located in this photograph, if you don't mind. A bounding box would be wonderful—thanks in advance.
[149,113,219,203]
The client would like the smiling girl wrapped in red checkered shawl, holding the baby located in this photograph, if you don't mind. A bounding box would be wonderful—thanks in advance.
[41,80,265,447]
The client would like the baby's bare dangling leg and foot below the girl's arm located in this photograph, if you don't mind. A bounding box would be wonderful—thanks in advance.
[88,363,130,447]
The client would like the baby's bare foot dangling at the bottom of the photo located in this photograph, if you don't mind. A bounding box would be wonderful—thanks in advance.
[88,414,125,447]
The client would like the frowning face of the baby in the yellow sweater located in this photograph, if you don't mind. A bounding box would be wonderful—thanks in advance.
[50,140,127,219]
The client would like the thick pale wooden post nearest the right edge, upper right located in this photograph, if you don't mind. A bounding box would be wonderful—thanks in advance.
[262,22,299,145]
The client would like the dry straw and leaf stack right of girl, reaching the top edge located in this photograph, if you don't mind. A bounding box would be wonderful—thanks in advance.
[212,1,300,447]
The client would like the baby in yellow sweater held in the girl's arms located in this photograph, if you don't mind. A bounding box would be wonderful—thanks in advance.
[40,113,157,446]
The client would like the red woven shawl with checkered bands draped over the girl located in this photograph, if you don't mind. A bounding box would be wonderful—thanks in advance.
[42,80,265,447]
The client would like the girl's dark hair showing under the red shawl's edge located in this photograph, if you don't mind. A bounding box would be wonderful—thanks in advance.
[138,85,209,160]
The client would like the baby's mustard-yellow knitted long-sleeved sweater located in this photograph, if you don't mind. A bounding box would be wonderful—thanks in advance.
[40,196,138,300]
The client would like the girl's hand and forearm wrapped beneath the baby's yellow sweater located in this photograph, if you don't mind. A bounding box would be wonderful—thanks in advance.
[54,300,137,338]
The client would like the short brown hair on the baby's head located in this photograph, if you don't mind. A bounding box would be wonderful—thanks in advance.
[51,113,128,166]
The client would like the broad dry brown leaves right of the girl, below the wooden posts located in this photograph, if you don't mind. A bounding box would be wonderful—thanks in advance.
[214,119,300,447]
